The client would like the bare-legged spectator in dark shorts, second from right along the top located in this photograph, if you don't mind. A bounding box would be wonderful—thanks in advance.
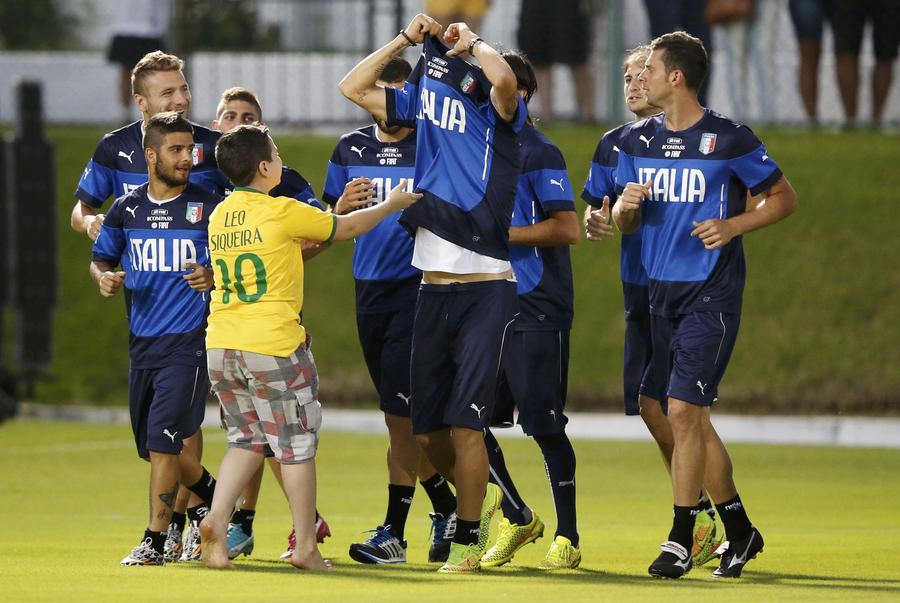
[790,0,832,125]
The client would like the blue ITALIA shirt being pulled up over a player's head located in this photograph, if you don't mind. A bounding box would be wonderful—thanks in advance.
[385,37,527,260]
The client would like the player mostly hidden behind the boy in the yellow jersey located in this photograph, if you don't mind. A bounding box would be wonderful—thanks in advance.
[212,86,331,559]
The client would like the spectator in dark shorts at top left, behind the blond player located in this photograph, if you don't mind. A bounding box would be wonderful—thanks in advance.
[107,0,169,121]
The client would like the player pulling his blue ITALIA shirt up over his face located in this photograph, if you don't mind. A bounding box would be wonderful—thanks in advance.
[340,14,527,572]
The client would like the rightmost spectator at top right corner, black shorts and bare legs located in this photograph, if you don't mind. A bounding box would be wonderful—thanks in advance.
[831,0,900,127]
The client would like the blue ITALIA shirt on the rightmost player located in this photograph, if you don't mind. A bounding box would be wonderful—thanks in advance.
[615,110,781,316]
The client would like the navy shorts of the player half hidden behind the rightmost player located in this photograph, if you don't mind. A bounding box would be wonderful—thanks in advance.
[622,282,657,415]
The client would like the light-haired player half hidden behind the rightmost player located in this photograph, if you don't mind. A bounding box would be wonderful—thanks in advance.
[581,46,724,566]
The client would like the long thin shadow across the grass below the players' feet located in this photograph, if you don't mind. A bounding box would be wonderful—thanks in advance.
[193,559,900,593]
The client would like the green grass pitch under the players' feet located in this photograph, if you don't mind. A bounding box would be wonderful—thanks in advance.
[0,422,900,602]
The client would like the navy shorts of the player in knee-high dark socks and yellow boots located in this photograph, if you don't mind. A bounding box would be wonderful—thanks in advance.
[491,329,569,436]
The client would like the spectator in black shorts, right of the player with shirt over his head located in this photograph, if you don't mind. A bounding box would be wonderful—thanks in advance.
[518,0,594,122]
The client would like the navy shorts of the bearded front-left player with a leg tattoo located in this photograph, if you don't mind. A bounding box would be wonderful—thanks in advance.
[128,365,209,458]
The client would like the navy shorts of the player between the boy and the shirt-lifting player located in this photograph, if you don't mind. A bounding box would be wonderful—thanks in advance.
[356,308,415,417]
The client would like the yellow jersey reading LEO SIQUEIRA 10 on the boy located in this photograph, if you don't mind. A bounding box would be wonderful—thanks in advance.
[206,187,337,357]
